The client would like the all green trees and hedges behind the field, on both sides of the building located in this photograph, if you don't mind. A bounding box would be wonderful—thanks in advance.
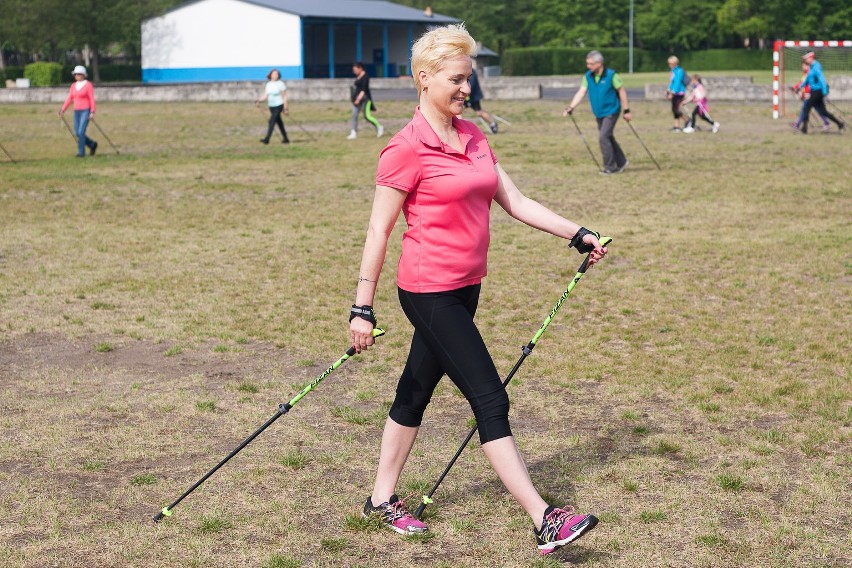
[0,0,852,81]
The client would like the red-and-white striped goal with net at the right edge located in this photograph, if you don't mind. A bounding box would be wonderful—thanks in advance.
[772,40,852,122]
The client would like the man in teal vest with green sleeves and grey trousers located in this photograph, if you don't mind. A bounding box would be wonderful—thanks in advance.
[562,51,632,175]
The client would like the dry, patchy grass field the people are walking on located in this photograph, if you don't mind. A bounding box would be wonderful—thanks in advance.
[0,101,852,568]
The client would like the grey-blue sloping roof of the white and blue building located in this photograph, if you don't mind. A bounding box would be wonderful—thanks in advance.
[156,0,461,25]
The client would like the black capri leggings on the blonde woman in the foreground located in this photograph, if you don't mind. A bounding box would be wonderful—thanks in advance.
[389,284,512,444]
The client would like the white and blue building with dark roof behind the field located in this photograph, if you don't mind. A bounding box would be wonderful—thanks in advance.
[142,0,459,83]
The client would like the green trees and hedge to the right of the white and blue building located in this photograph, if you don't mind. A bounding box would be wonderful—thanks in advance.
[396,0,852,53]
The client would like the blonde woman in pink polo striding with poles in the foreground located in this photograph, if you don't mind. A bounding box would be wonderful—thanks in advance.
[349,24,607,554]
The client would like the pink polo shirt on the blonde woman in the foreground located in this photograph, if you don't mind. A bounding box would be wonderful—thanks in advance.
[376,107,497,292]
